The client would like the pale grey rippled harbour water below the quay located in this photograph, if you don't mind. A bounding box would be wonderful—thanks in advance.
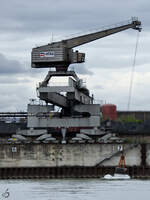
[0,179,150,200]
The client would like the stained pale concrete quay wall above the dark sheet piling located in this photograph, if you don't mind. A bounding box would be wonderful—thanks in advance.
[0,143,144,168]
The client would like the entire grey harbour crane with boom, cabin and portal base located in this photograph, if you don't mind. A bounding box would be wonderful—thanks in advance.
[21,18,141,143]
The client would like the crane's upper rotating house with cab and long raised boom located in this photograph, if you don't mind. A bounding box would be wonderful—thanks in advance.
[32,18,141,72]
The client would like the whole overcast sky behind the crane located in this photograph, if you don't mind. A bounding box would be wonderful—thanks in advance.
[0,0,150,112]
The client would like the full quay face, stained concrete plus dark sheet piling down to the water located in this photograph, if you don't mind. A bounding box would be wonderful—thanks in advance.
[0,143,150,179]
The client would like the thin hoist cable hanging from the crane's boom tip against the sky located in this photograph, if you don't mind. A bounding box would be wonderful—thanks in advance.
[127,31,140,111]
